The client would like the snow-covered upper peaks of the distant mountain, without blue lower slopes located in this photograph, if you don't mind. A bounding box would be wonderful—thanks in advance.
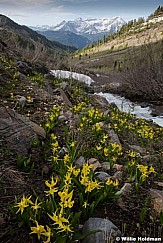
[31,17,126,35]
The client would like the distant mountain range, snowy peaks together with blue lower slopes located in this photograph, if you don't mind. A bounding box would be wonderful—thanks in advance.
[30,17,126,49]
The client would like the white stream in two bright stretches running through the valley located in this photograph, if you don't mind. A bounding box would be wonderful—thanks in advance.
[51,70,163,127]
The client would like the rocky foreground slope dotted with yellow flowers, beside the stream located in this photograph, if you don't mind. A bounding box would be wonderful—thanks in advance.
[0,40,163,243]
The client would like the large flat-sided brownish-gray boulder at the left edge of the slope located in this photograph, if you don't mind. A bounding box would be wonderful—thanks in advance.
[0,107,46,156]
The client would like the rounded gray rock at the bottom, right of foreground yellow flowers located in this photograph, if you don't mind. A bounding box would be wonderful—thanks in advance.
[83,218,121,243]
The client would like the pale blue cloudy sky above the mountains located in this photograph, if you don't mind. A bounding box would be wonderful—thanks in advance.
[0,0,163,26]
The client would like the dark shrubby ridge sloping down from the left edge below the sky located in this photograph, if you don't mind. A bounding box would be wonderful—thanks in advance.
[0,14,75,67]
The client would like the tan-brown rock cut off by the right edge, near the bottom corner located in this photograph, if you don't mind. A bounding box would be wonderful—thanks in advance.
[150,189,163,215]
